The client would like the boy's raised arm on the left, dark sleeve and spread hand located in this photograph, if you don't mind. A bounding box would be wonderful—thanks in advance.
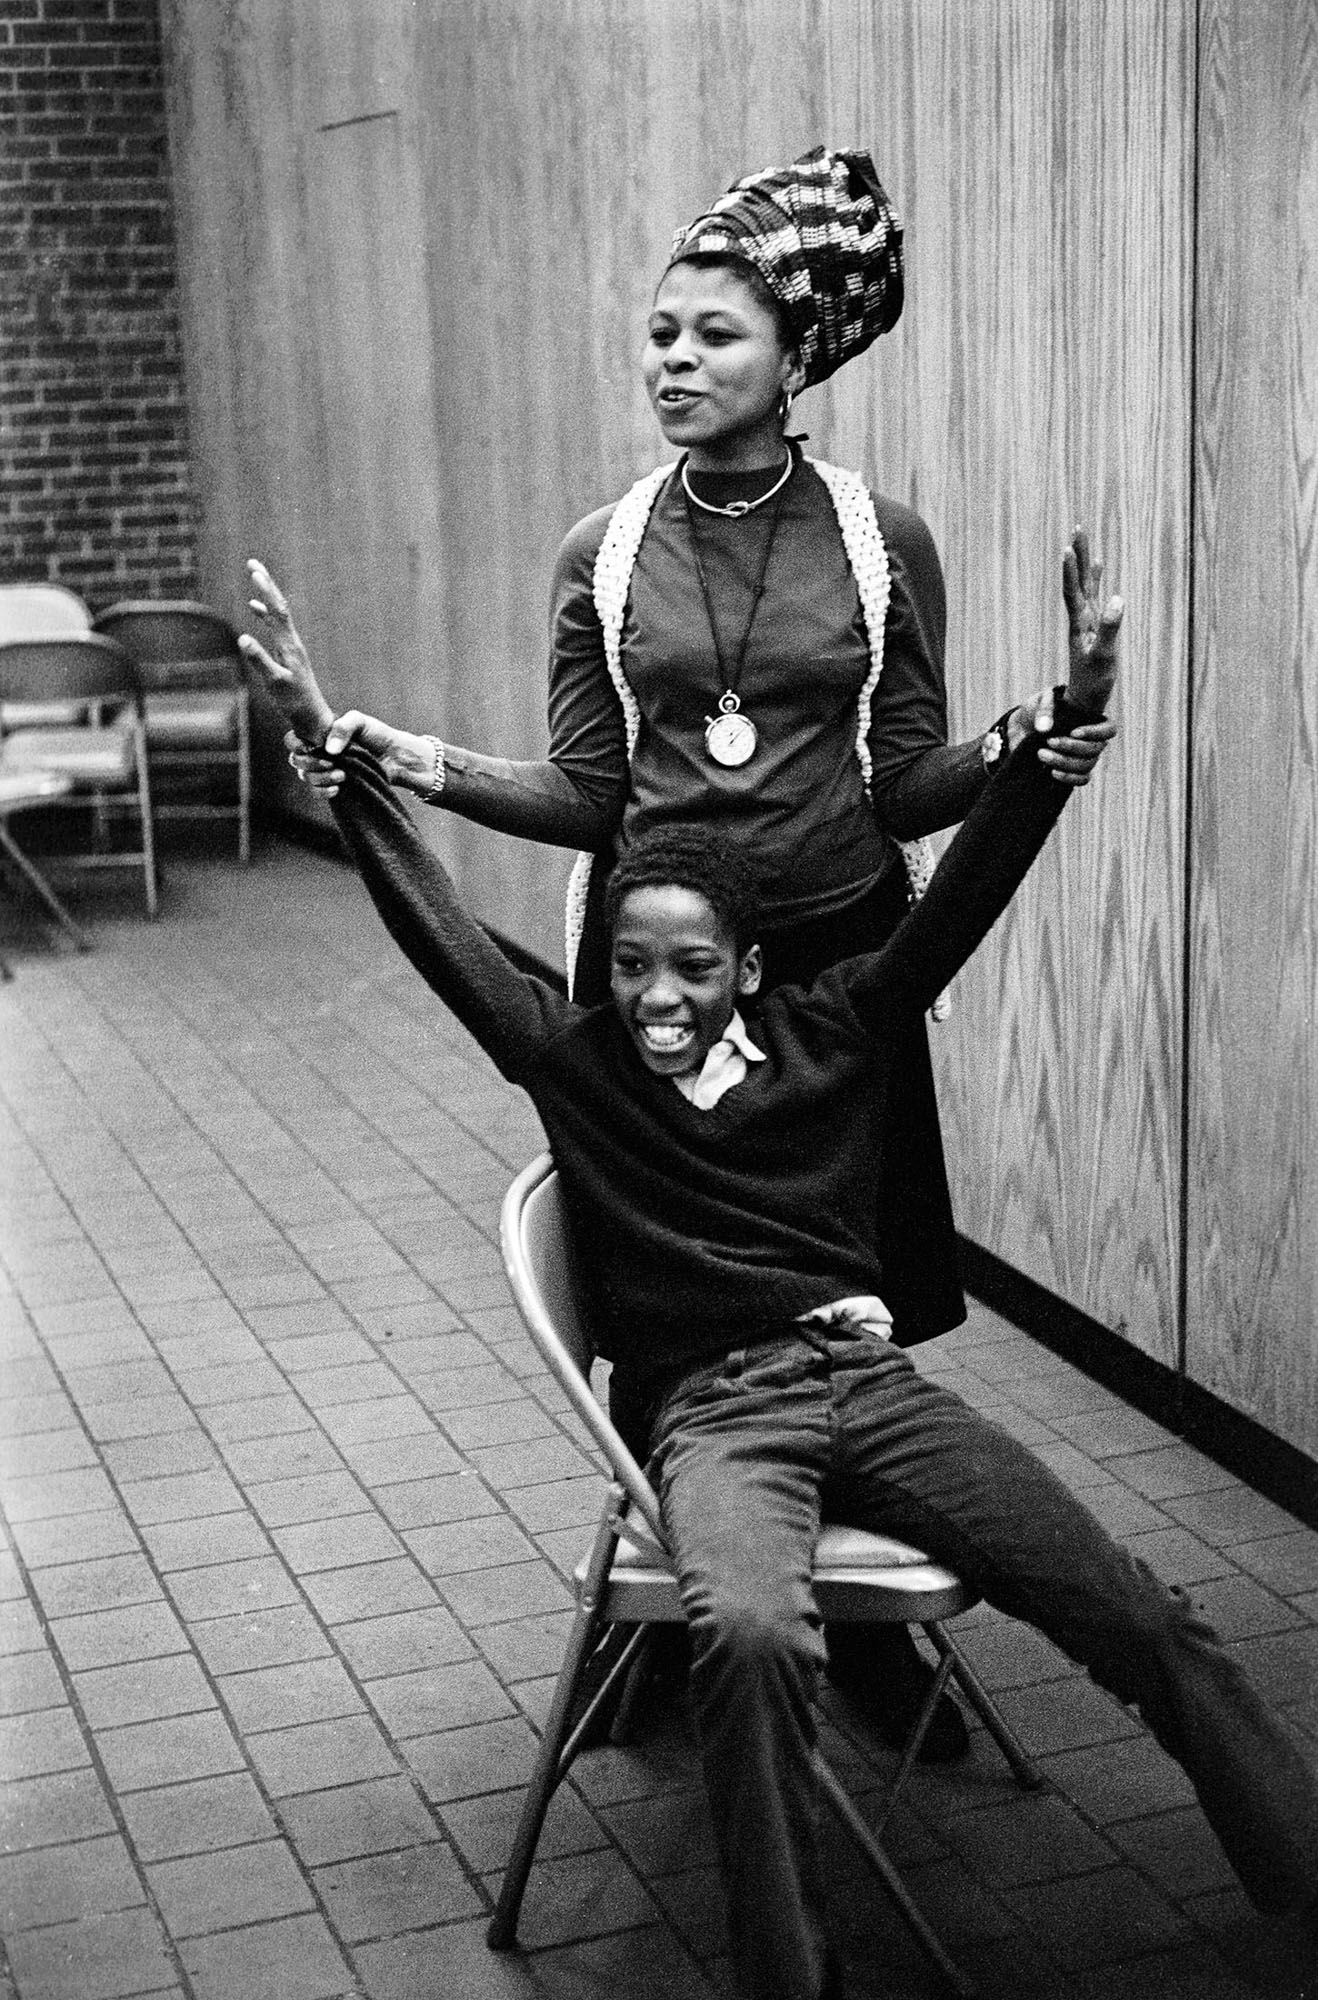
[238,562,570,1082]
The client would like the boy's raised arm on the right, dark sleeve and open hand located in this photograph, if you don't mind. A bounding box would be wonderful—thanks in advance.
[840,528,1124,1016]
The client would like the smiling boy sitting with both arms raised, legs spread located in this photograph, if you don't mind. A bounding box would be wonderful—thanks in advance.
[244,538,1318,2000]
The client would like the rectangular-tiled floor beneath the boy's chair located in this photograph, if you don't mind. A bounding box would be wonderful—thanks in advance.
[0,850,1318,2000]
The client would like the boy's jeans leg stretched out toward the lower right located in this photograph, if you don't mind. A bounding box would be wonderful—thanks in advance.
[826,1350,1318,1912]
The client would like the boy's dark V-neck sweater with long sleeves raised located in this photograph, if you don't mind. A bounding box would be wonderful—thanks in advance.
[334,702,1082,1380]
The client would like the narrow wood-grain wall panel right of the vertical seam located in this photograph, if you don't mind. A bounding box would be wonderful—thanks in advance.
[1186,0,1318,1454]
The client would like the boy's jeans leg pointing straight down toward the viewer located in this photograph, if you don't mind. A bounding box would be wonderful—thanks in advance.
[652,1340,830,2000]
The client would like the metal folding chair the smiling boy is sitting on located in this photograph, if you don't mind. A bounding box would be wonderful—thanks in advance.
[488,1154,1042,1994]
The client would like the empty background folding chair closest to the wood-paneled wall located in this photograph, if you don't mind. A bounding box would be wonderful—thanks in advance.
[96,598,252,862]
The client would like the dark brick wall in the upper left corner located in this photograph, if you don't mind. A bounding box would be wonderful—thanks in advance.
[0,0,196,608]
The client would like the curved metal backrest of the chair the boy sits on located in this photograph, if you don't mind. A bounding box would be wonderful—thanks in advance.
[500,1152,664,1542]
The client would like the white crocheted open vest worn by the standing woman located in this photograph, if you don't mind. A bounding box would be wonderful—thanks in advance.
[566,458,948,1020]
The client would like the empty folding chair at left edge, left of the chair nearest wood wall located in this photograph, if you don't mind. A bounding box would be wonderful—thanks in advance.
[0,632,158,916]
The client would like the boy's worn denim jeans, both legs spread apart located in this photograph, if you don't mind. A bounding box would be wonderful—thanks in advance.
[654,1324,1318,2000]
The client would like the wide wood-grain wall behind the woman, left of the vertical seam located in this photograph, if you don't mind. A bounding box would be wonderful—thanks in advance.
[157,0,1312,1436]
